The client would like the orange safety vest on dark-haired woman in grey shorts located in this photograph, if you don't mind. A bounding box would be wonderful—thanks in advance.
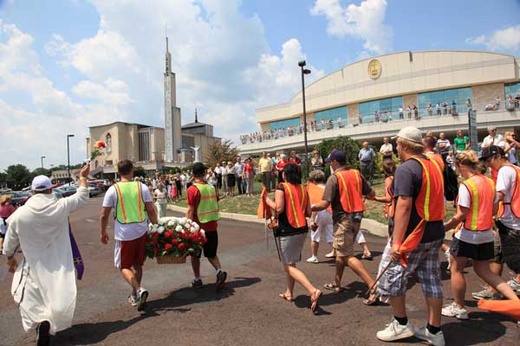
[282,183,309,228]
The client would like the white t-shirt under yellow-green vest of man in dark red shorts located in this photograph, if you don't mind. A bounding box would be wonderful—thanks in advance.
[103,183,153,241]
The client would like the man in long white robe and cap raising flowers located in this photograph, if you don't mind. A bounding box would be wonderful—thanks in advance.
[3,166,89,345]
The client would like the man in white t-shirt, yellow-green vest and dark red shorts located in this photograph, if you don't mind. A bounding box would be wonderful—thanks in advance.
[100,160,157,311]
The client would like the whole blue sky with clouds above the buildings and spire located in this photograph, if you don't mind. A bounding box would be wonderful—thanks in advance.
[0,0,520,170]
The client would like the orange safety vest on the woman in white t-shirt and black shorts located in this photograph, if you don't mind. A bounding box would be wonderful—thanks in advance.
[457,174,496,231]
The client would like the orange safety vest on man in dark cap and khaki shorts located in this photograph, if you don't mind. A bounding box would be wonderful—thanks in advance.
[334,169,365,213]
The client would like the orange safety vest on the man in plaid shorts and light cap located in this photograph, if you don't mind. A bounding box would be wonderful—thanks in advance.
[412,156,446,222]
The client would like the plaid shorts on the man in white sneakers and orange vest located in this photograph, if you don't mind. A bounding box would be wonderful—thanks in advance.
[378,239,443,298]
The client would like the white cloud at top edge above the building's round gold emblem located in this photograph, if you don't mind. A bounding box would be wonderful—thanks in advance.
[311,0,393,54]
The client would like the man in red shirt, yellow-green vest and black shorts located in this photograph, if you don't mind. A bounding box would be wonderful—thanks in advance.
[186,162,227,292]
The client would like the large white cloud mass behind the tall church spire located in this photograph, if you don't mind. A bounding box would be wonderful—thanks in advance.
[0,0,324,169]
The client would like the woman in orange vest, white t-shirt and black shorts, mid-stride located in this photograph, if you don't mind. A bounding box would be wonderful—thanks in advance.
[442,150,518,320]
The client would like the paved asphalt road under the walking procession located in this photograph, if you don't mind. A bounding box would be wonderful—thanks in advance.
[0,198,520,346]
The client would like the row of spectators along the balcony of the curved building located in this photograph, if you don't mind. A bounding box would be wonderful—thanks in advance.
[240,94,520,144]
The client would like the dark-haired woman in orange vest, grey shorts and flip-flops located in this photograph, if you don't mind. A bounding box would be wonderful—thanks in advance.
[266,163,322,313]
